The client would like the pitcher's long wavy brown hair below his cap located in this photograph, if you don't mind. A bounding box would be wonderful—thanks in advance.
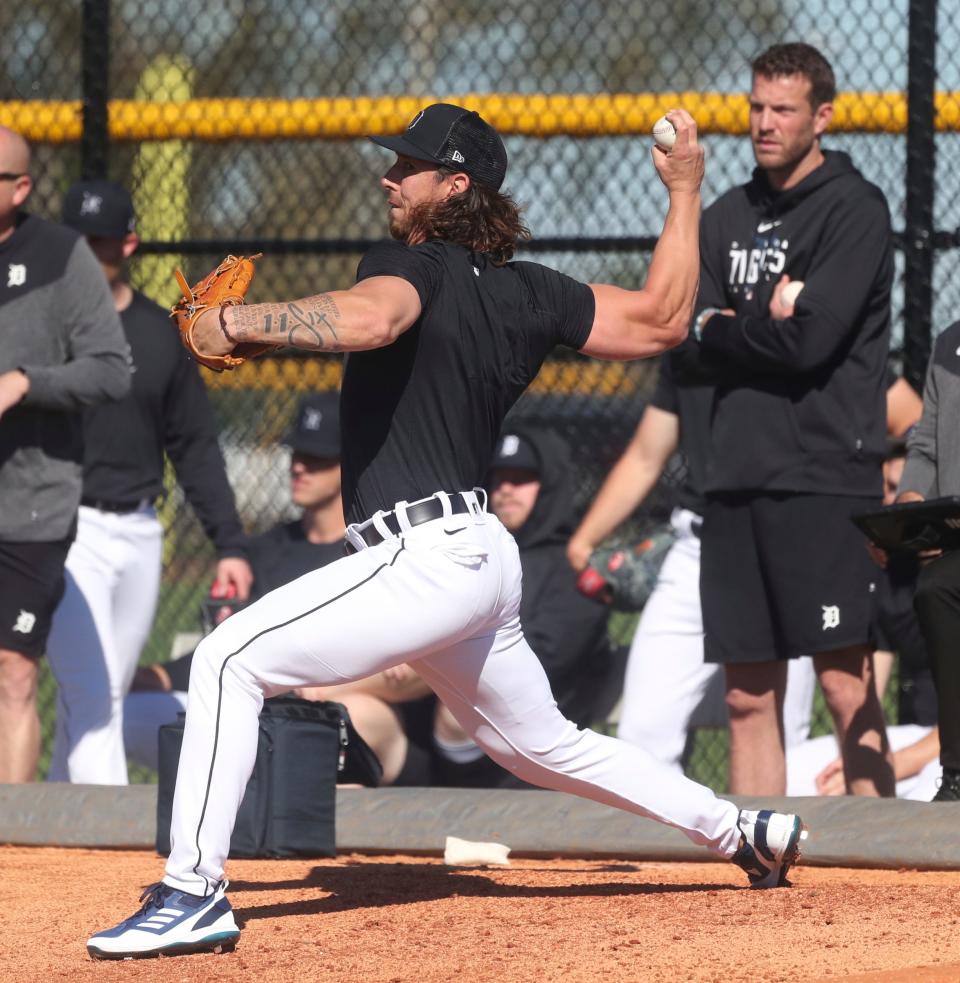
[406,167,530,266]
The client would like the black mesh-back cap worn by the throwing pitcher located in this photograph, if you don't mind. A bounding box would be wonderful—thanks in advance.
[370,102,507,191]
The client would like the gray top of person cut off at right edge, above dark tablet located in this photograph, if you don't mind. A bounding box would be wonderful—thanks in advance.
[898,321,960,498]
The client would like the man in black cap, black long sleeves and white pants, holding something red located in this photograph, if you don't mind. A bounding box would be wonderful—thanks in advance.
[48,180,253,785]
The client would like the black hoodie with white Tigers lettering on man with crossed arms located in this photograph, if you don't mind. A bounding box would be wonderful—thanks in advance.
[697,151,893,495]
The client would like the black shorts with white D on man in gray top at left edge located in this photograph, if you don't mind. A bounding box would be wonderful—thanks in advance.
[0,539,71,659]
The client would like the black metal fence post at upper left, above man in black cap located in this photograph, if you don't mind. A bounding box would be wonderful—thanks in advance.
[80,0,110,179]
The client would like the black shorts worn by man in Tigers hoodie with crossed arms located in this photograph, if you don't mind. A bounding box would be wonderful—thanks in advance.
[700,494,880,663]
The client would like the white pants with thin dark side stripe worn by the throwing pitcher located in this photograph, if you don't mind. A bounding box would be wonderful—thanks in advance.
[164,492,740,894]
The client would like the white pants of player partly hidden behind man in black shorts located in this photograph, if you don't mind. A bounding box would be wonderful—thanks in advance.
[617,509,816,771]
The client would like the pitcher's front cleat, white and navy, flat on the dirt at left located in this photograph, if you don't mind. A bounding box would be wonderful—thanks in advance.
[87,881,240,959]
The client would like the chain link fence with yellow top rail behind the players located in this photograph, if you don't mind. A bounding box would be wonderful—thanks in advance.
[0,0,944,788]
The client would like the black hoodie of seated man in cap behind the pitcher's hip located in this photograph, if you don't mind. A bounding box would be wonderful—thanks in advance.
[492,427,611,726]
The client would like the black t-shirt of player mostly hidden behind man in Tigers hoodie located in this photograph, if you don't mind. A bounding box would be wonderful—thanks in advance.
[650,350,716,515]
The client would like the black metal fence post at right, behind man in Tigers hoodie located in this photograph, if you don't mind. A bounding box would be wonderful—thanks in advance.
[903,0,938,389]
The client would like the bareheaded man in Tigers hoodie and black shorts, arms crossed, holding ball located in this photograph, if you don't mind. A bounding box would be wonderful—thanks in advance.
[693,44,894,795]
